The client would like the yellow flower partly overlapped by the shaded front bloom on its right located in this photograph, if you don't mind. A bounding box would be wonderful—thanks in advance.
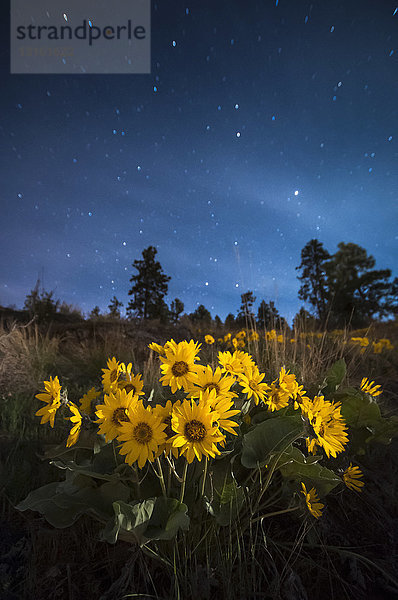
[95,389,137,442]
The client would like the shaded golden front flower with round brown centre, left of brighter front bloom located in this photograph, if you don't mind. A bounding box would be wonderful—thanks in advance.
[118,400,166,469]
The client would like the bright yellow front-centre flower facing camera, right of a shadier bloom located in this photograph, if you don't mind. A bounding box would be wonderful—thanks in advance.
[170,400,225,463]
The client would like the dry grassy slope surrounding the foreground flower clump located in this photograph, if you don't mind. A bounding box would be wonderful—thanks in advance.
[0,316,398,600]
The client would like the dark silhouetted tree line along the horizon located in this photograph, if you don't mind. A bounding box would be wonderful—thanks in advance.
[19,239,398,329]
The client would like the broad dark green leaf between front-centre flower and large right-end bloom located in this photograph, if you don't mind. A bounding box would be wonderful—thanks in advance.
[241,415,303,469]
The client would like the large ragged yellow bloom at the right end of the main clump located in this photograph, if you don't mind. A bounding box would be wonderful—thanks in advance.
[301,396,348,458]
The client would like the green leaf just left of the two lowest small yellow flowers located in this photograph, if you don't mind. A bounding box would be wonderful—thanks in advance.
[279,447,341,496]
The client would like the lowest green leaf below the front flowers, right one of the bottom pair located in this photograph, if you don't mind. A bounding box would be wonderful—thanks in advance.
[144,497,189,541]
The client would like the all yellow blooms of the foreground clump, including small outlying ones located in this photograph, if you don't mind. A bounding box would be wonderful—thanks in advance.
[36,336,372,517]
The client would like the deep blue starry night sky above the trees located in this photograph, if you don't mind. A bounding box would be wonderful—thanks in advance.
[0,0,398,320]
